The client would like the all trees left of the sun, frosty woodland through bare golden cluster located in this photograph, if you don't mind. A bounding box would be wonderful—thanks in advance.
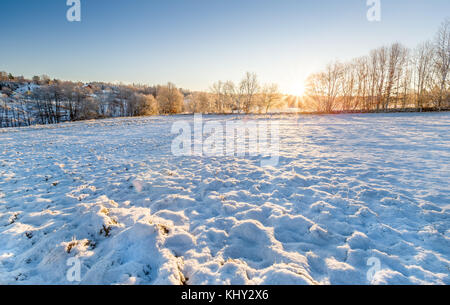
[0,72,282,127]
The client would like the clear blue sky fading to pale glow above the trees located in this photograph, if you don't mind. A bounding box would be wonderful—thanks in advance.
[0,0,450,93]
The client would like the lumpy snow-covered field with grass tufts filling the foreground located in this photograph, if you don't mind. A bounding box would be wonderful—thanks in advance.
[0,113,450,284]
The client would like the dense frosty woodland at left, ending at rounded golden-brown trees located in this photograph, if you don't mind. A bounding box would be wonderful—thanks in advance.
[0,78,185,127]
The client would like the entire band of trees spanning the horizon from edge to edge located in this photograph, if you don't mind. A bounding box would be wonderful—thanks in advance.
[0,19,450,127]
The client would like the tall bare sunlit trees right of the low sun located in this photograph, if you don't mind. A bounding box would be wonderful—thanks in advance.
[303,19,450,113]
